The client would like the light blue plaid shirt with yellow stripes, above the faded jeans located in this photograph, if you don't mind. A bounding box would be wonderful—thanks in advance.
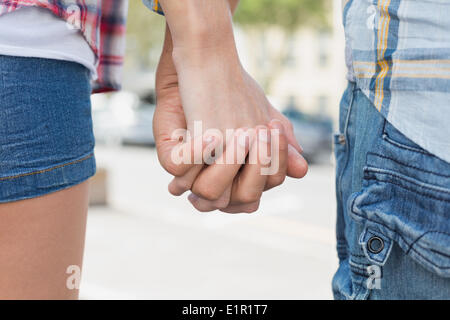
[344,0,450,162]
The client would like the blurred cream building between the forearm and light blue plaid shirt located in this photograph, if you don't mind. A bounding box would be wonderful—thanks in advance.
[237,0,346,120]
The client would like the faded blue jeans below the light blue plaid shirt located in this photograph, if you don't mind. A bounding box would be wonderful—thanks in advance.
[333,83,450,299]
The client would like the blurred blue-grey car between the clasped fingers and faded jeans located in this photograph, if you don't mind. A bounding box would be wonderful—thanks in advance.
[283,107,333,163]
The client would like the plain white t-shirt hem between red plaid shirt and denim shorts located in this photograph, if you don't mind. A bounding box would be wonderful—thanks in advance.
[0,7,97,79]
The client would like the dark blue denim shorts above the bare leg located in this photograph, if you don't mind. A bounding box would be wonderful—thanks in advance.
[0,55,96,203]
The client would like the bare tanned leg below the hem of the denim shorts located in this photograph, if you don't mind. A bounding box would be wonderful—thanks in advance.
[0,182,89,299]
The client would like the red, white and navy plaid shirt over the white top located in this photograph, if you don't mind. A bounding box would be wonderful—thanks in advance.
[0,0,128,93]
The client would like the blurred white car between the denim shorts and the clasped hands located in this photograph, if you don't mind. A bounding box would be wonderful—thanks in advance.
[92,92,155,146]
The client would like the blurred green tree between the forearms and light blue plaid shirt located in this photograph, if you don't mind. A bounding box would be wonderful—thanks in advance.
[234,0,332,93]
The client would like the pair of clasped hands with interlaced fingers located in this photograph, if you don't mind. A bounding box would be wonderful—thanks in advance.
[153,28,308,213]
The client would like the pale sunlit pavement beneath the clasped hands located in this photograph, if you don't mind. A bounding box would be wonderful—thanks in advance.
[81,147,338,299]
